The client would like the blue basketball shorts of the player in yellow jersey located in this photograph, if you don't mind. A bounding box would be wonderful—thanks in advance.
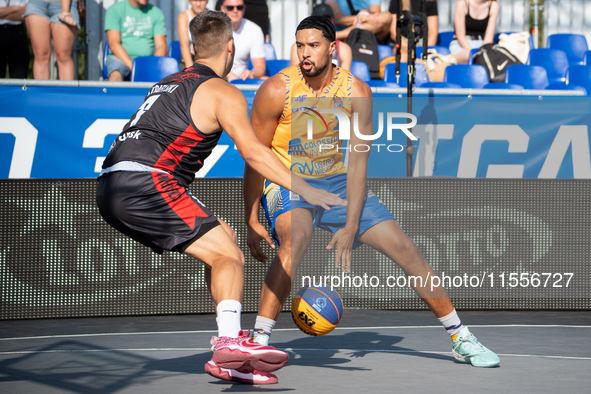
[261,174,396,248]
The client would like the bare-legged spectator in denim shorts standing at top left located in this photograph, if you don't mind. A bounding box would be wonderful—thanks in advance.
[25,0,80,81]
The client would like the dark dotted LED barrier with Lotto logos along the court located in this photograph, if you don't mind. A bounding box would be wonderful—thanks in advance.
[0,178,591,319]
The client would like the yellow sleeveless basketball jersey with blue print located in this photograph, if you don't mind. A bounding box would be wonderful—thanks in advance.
[271,64,353,178]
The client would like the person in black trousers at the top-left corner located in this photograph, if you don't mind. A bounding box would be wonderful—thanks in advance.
[0,0,29,78]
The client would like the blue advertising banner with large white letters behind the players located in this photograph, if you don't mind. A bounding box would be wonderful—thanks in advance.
[0,85,591,179]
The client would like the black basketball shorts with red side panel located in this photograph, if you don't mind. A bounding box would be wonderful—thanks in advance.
[96,171,220,253]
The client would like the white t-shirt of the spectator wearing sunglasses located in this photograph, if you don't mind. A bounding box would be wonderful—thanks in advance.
[232,19,265,76]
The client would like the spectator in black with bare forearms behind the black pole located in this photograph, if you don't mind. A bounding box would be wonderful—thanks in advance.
[388,0,439,63]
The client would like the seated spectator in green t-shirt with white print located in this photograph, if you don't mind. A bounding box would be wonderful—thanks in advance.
[105,0,167,81]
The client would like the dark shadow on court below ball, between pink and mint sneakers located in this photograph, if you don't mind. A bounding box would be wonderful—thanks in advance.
[273,331,453,371]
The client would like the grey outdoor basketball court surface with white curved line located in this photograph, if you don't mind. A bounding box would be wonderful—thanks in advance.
[0,309,591,394]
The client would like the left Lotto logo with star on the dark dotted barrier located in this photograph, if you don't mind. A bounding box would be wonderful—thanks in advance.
[0,185,213,318]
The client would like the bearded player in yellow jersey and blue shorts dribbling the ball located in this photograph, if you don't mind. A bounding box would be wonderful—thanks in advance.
[244,16,499,382]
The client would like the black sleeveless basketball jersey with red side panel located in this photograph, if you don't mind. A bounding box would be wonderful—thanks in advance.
[103,63,222,186]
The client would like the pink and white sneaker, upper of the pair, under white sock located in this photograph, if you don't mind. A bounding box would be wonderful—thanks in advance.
[211,331,289,372]
